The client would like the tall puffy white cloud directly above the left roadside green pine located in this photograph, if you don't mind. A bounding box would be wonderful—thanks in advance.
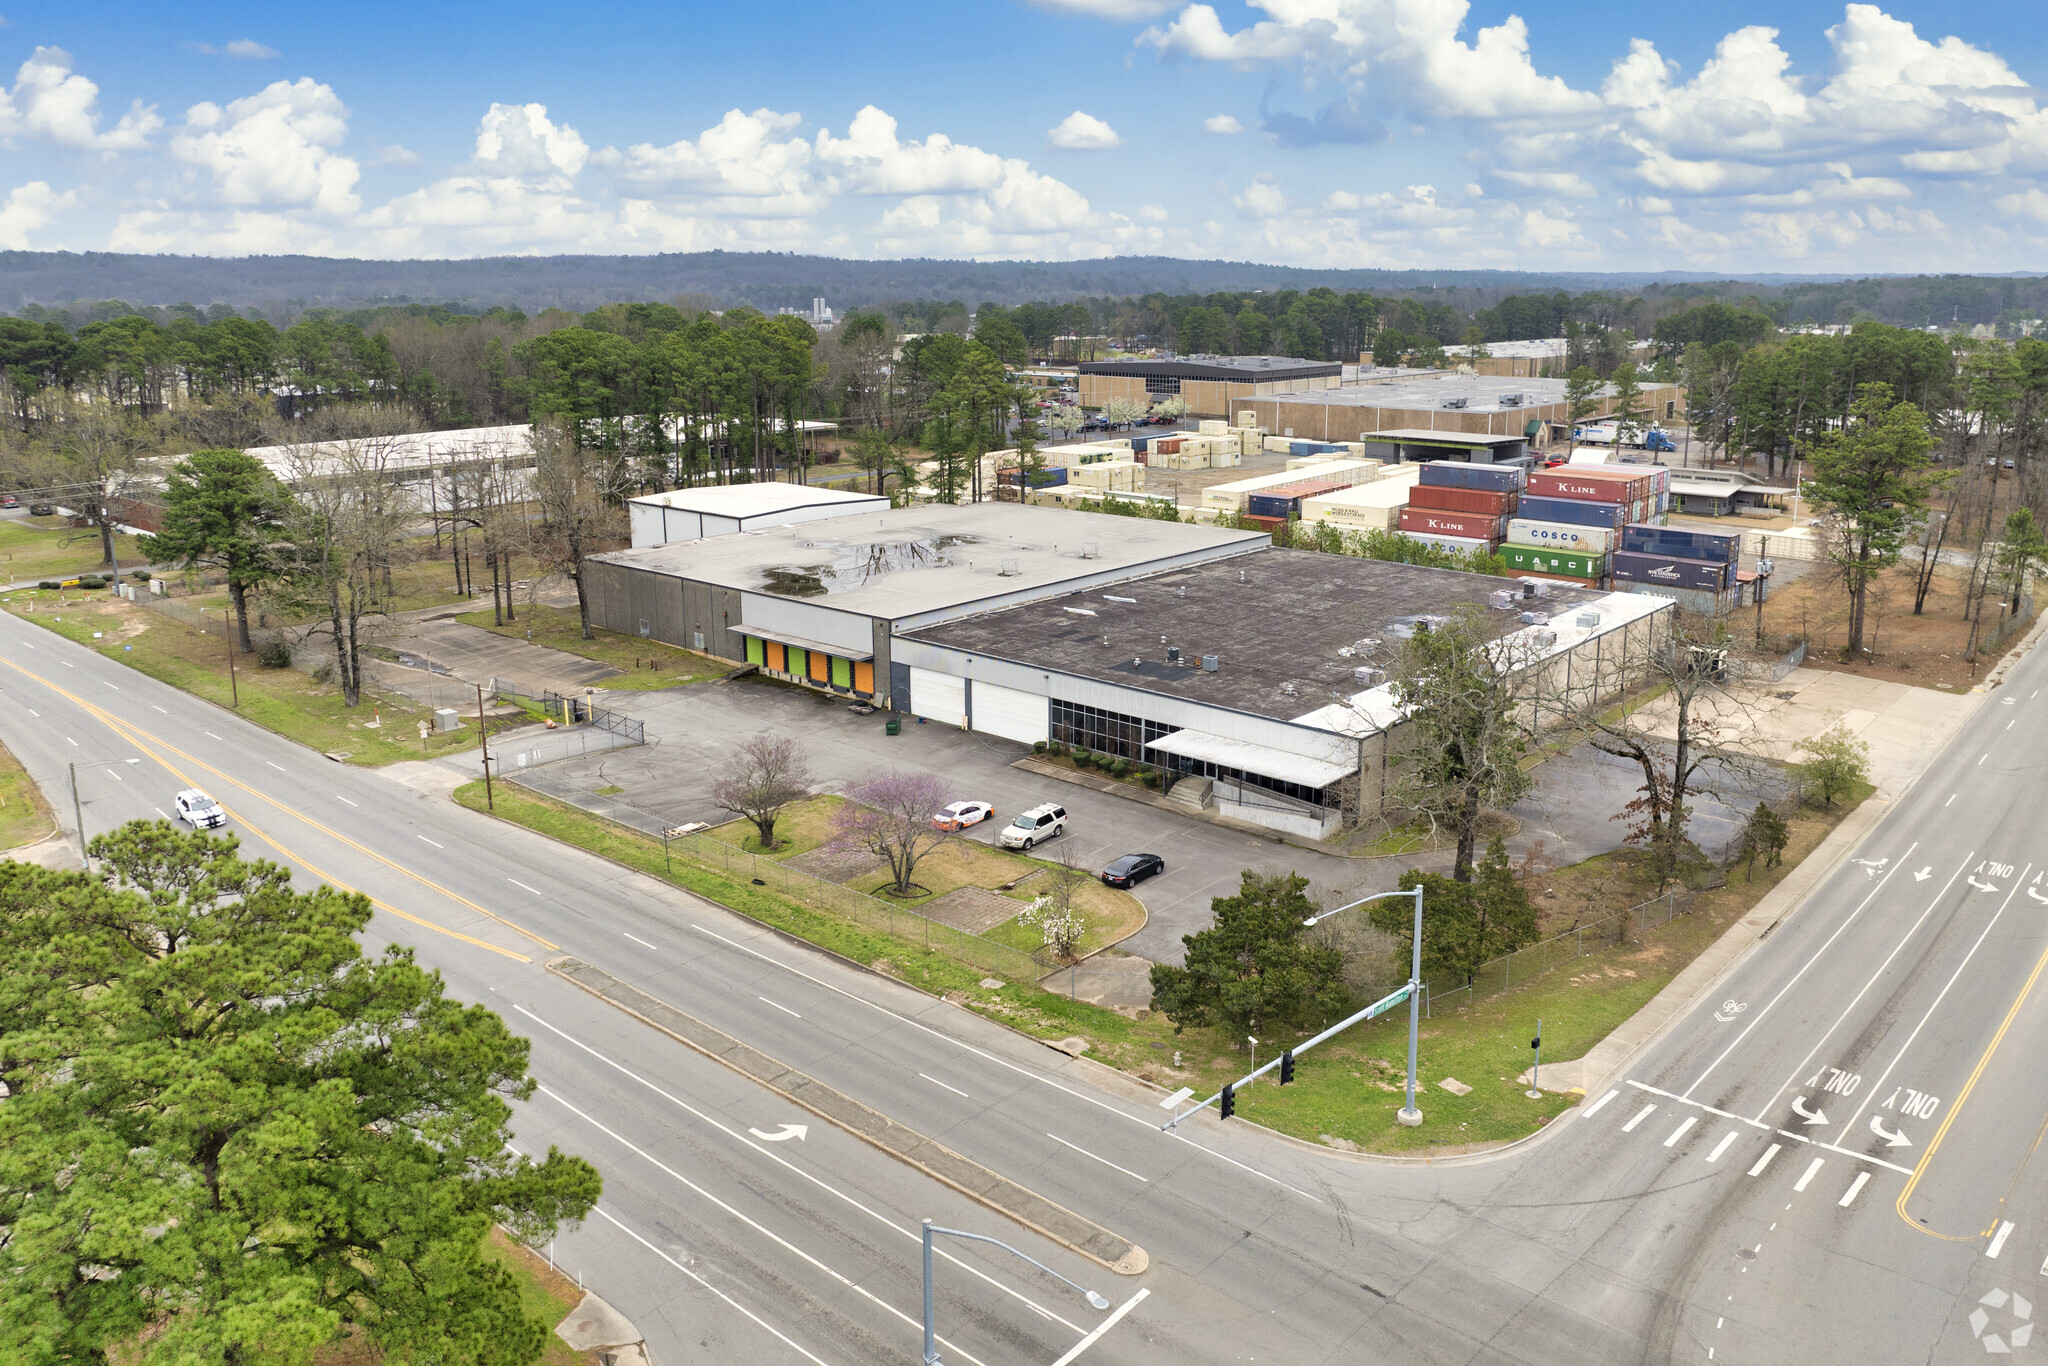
[170,76,360,215]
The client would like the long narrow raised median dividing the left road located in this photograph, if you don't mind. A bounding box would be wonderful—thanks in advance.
[547,956,1151,1276]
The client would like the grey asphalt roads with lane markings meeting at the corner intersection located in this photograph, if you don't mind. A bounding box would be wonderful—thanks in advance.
[0,618,2048,1366]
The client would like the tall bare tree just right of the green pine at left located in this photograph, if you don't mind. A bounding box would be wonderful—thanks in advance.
[285,405,418,707]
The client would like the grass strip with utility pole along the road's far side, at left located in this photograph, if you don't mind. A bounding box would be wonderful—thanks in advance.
[4,590,491,766]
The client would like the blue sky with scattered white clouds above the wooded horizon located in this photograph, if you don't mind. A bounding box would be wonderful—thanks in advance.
[0,0,2048,272]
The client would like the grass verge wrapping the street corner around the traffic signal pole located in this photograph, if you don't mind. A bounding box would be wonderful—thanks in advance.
[457,770,1868,1153]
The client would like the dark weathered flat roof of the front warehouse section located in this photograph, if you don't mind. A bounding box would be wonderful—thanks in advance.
[905,549,1608,721]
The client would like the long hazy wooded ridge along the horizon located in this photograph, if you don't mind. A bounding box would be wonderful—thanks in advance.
[0,252,1884,311]
